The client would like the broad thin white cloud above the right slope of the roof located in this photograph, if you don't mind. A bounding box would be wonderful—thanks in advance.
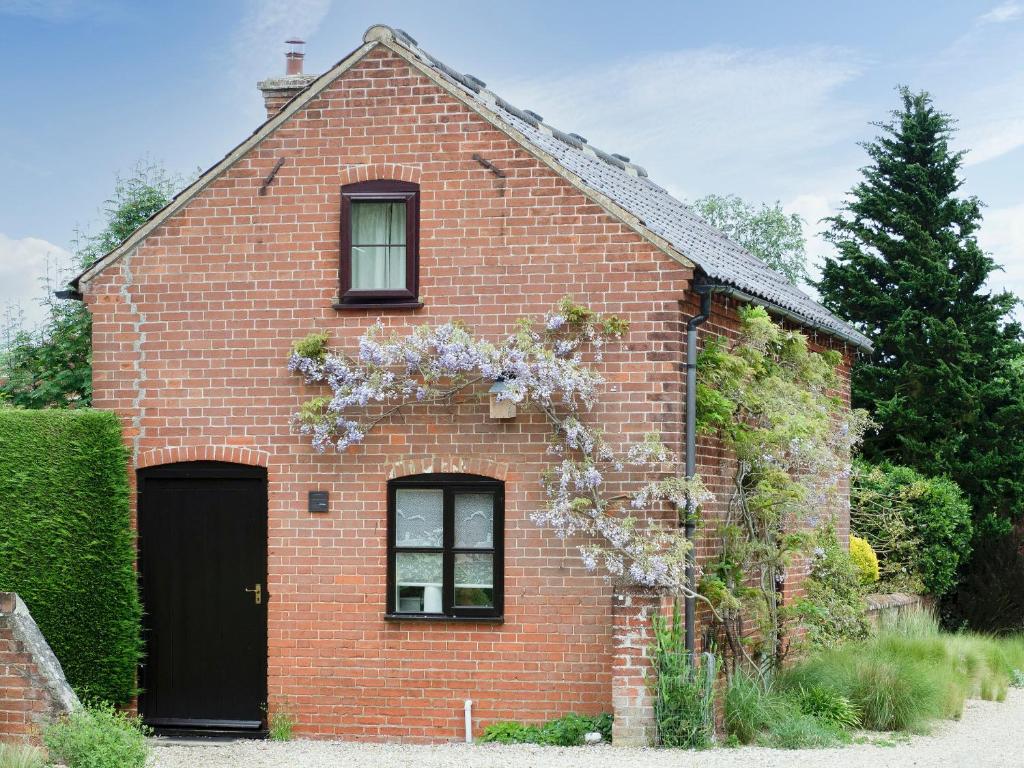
[494,47,870,199]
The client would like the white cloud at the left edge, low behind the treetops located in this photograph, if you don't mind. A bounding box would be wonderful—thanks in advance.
[0,232,71,325]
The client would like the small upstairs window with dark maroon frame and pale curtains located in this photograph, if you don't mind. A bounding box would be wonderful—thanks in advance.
[338,181,420,308]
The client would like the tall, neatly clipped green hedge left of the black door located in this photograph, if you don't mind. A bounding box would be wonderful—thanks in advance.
[0,408,141,705]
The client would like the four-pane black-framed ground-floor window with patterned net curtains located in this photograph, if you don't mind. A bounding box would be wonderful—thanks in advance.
[387,474,505,618]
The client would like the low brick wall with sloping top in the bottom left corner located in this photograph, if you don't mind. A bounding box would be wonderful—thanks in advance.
[0,592,81,741]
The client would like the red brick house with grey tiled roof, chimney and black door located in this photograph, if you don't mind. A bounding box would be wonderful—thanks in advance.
[68,26,867,741]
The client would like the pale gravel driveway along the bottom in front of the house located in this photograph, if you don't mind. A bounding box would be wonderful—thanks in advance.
[152,689,1024,768]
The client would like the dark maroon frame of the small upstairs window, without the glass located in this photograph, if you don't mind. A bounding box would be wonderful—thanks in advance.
[335,179,422,309]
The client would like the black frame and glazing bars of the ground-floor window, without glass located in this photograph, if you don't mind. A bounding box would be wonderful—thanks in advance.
[385,473,505,622]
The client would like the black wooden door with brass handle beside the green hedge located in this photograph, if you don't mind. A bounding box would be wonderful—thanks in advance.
[138,462,268,729]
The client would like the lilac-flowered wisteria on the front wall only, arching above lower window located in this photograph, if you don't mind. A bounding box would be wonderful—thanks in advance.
[288,298,712,597]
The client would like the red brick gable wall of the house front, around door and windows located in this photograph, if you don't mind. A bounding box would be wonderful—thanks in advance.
[79,43,851,739]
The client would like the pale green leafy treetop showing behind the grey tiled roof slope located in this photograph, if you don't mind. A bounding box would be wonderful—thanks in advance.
[691,195,808,284]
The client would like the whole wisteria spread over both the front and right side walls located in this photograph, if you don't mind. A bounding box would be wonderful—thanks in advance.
[289,299,866,655]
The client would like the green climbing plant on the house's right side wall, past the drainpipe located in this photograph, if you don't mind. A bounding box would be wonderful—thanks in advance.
[697,307,869,667]
